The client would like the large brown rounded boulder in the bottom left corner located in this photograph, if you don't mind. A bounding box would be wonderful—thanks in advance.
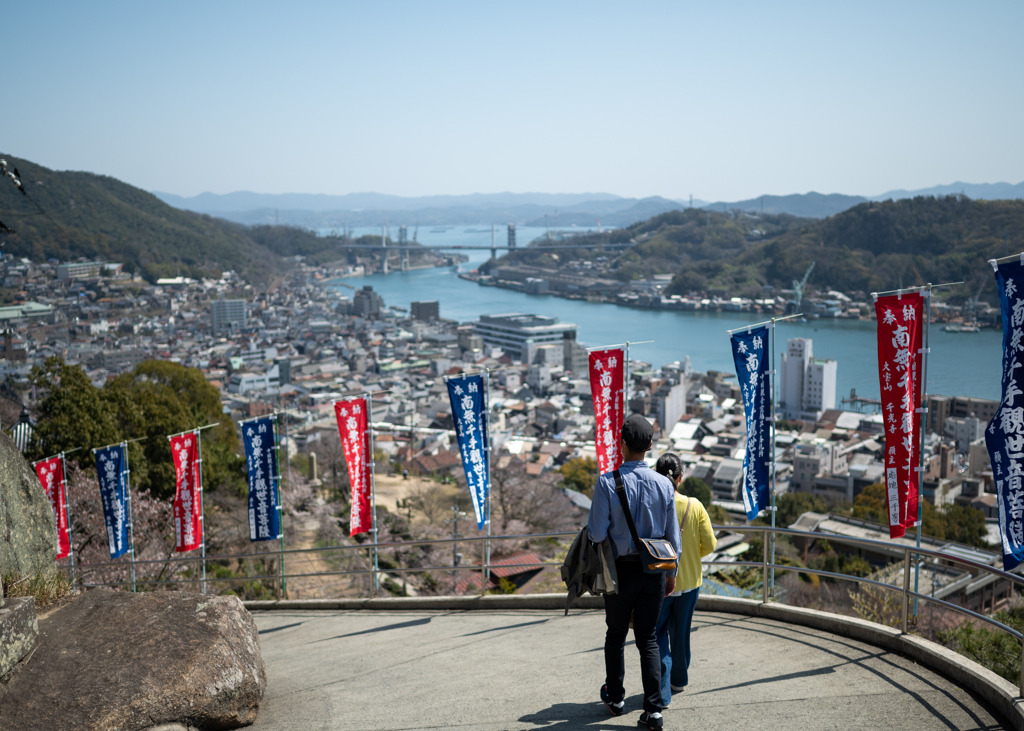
[0,589,266,731]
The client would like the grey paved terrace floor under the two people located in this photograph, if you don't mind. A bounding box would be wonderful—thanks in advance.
[252,610,1002,731]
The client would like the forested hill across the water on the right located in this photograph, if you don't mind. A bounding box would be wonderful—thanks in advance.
[507,196,1024,301]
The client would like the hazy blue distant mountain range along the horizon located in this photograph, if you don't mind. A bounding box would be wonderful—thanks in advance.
[153,182,1024,228]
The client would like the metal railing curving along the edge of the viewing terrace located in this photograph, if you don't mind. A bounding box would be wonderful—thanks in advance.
[70,525,1024,697]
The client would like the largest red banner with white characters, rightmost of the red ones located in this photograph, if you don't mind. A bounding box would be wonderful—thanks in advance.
[874,292,924,539]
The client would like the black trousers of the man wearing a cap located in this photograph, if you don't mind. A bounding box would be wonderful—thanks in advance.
[604,558,665,713]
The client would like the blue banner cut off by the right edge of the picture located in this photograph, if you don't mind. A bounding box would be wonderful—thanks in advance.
[985,260,1024,571]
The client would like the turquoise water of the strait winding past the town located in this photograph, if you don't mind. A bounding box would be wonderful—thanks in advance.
[325,226,1001,406]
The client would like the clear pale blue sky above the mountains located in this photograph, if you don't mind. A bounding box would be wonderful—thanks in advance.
[0,0,1024,201]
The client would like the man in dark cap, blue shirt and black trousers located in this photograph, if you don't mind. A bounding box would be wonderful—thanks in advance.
[589,414,680,729]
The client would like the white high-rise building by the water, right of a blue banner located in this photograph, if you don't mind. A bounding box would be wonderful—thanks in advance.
[778,338,838,421]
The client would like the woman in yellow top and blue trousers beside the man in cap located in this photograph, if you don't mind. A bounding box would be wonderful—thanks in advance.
[654,453,718,706]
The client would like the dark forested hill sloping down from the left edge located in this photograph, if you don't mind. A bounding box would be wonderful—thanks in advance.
[0,154,380,283]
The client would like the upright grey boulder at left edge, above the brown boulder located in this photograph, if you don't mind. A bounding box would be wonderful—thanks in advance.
[0,432,56,576]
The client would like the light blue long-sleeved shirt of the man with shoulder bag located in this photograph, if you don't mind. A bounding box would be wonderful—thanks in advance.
[587,461,682,576]
